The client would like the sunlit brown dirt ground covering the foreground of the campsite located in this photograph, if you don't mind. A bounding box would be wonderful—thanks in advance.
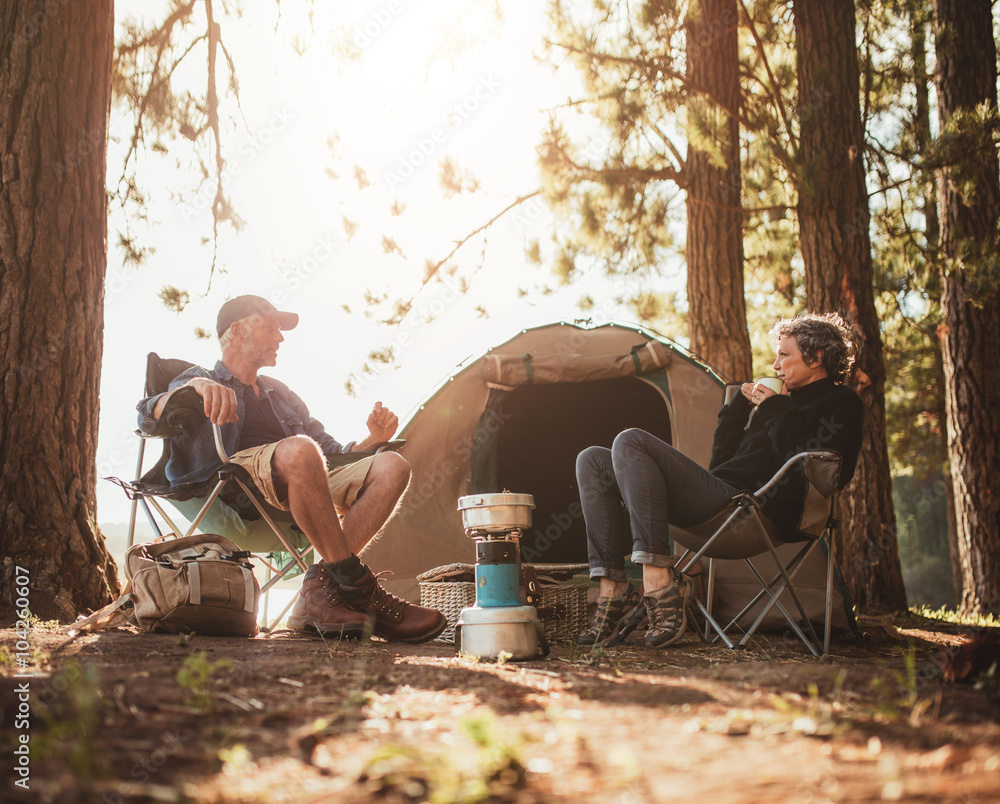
[0,614,1000,804]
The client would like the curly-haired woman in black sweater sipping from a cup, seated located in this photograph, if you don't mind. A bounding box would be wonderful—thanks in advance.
[576,313,864,648]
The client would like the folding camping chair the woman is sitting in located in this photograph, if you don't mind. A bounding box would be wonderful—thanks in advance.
[670,451,840,656]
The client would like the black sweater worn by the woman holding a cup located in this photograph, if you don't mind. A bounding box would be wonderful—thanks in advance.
[708,377,864,538]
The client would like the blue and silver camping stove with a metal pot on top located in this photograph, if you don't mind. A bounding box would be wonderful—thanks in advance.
[455,492,548,660]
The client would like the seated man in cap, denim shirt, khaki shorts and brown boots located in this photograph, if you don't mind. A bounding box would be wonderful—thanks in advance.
[138,296,447,643]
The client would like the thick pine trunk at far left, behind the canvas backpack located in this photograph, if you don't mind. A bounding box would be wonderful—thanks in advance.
[0,0,118,619]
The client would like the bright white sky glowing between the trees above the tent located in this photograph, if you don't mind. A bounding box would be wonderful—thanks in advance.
[98,0,668,522]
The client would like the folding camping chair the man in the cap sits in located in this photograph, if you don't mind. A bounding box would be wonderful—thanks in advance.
[105,352,312,630]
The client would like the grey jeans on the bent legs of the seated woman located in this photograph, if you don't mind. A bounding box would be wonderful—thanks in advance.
[576,428,739,581]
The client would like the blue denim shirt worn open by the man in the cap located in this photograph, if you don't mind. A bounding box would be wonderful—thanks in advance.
[136,360,354,486]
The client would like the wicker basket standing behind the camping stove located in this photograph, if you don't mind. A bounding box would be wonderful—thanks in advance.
[417,564,588,644]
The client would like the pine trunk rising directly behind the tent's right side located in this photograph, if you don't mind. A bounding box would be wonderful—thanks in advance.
[684,0,752,380]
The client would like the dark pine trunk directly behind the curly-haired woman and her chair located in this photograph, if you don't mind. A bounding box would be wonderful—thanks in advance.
[794,0,906,611]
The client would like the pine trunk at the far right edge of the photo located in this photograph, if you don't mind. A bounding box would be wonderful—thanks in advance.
[934,0,1000,614]
